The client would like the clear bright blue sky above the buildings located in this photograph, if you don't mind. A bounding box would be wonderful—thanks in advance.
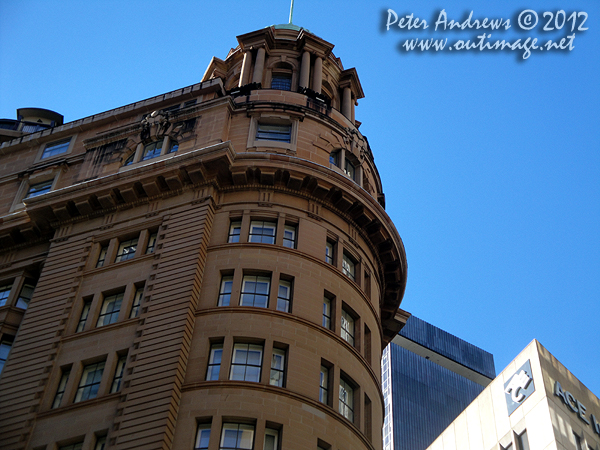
[0,0,600,395]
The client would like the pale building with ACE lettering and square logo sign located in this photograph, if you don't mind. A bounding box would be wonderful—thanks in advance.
[428,340,600,450]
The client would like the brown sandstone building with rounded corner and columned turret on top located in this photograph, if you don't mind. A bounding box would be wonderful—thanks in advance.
[0,25,406,450]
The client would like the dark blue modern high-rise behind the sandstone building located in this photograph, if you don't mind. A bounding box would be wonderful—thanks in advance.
[382,316,496,450]
